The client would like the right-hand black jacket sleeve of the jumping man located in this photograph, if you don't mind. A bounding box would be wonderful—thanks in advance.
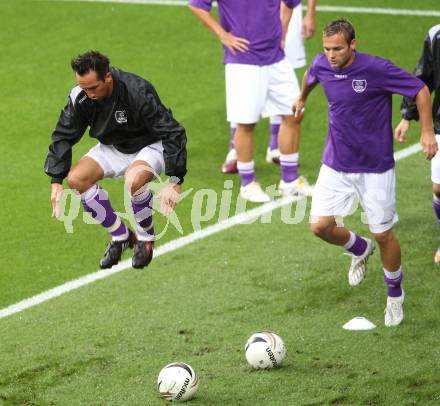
[140,85,186,183]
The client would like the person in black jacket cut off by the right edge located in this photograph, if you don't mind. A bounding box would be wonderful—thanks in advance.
[394,24,440,264]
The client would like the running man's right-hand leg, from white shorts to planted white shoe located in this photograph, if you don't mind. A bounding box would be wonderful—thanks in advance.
[358,169,404,327]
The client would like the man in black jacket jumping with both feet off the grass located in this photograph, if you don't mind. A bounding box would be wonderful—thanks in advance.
[44,51,186,268]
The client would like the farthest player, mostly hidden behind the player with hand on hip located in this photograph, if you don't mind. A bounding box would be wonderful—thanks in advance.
[222,0,316,173]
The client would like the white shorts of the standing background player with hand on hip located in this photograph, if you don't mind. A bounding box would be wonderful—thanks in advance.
[225,58,300,124]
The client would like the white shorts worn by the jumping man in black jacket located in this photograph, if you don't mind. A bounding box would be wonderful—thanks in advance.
[85,141,165,178]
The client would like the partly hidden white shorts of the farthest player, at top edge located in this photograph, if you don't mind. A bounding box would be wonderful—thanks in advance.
[284,4,306,69]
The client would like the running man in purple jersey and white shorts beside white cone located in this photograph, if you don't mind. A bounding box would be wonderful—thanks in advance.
[293,19,437,326]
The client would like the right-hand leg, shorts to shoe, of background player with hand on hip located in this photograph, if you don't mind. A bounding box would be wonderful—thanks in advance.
[263,59,312,196]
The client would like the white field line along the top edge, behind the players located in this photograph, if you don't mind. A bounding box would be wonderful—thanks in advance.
[44,0,440,17]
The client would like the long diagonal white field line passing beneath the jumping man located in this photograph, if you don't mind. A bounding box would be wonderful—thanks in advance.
[0,144,421,319]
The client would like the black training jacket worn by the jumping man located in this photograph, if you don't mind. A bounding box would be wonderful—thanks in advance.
[44,68,186,183]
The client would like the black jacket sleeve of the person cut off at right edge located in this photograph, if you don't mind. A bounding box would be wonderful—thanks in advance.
[400,35,434,120]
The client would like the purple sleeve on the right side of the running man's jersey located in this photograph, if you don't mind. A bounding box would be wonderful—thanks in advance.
[383,60,425,99]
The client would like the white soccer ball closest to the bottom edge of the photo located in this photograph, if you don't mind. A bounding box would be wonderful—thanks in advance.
[157,362,199,402]
